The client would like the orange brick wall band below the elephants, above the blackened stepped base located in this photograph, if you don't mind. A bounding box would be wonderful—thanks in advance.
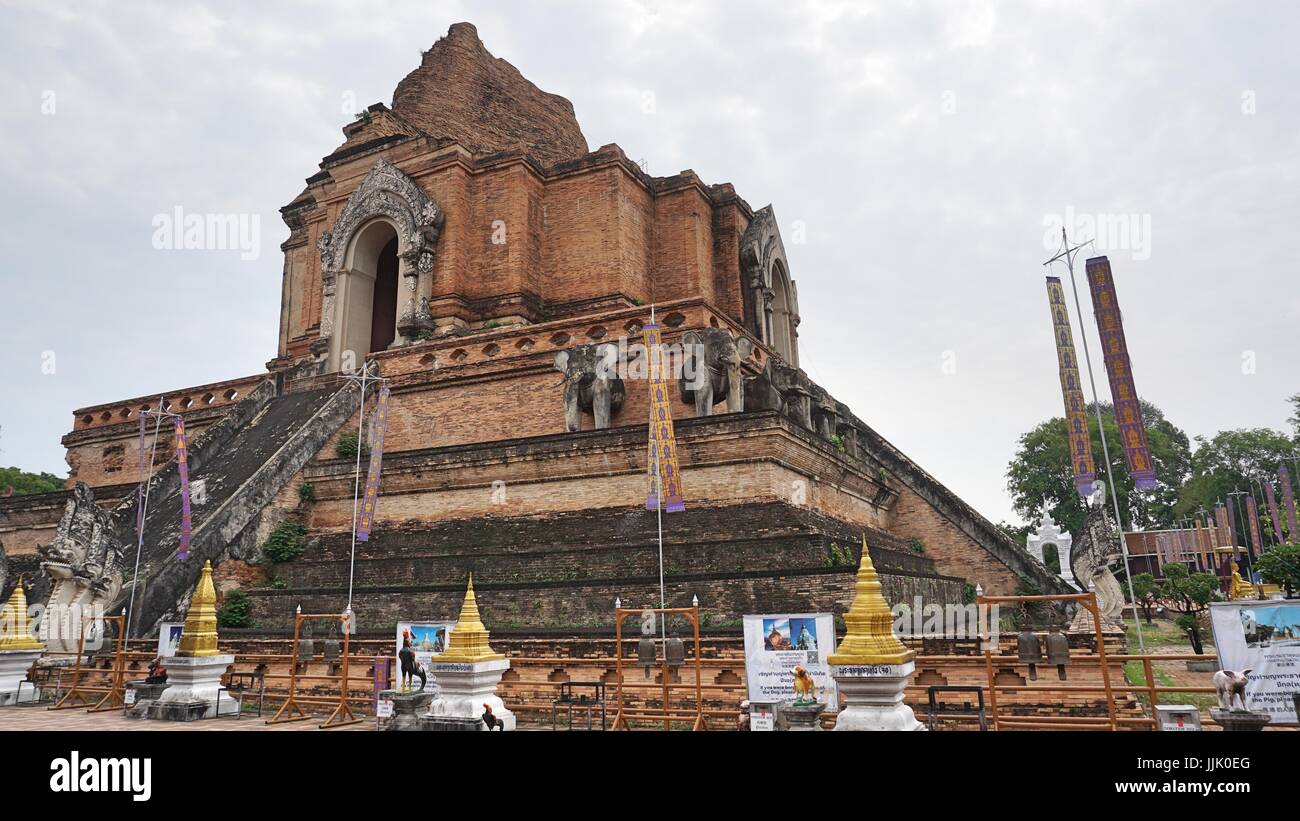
[307,407,888,531]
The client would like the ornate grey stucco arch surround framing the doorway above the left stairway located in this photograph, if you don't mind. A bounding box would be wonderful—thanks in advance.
[316,160,443,355]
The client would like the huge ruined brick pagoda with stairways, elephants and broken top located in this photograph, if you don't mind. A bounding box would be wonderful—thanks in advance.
[0,23,1061,634]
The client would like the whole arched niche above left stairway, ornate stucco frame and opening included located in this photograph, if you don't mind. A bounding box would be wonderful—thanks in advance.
[313,160,443,372]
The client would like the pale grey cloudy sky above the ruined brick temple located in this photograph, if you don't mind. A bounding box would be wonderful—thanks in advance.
[0,0,1300,521]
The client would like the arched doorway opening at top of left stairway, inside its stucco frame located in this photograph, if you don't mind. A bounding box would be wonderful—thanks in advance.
[337,218,399,370]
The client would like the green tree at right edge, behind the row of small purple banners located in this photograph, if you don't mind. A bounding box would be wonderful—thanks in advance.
[1174,427,1296,544]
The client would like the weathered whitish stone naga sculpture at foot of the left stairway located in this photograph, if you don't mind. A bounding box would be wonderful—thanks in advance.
[38,482,125,653]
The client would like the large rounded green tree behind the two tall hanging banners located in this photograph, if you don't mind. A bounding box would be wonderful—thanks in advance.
[1006,401,1192,537]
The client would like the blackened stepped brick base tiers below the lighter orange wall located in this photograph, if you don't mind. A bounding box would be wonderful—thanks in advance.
[239,503,962,629]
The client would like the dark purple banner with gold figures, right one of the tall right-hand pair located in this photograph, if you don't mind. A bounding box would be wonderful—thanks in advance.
[1088,257,1156,490]
